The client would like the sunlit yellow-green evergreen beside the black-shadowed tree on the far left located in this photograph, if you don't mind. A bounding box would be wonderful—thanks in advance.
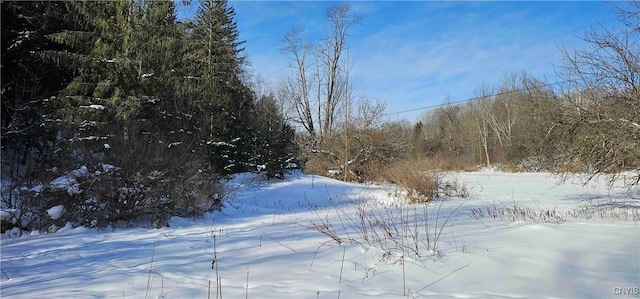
[46,1,144,157]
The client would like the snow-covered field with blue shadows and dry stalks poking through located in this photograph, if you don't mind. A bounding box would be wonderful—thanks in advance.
[0,171,640,298]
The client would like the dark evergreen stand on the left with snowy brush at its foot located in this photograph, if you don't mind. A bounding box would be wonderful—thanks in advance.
[2,0,294,232]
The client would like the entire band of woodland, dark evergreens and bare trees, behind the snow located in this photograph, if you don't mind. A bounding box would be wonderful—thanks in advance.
[1,0,640,231]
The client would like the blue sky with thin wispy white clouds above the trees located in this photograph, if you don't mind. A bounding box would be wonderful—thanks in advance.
[179,1,616,121]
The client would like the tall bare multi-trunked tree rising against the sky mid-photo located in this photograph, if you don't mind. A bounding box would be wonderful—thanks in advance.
[281,5,360,142]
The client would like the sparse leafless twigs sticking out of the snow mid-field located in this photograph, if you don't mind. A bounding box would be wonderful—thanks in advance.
[302,190,466,262]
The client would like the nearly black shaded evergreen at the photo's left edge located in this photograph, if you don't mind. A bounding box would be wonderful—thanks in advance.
[0,1,72,180]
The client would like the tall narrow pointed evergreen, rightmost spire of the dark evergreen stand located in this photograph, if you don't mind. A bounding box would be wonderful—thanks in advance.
[191,0,254,174]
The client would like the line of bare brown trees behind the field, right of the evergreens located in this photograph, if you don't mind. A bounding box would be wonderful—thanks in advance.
[278,1,640,186]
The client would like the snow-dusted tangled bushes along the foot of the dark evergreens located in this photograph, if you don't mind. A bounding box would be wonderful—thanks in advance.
[2,146,222,232]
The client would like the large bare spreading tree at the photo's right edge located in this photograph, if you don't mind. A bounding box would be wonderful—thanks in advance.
[545,1,640,185]
